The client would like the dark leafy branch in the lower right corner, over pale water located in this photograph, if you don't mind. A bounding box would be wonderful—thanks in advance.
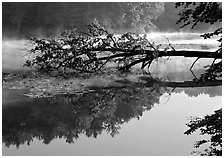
[184,109,222,156]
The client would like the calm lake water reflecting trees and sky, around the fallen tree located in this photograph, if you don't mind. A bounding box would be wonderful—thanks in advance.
[2,32,222,156]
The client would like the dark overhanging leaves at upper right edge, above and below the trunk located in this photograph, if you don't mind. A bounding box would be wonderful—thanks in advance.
[176,2,222,81]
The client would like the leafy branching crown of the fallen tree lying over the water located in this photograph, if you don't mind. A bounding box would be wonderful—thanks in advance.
[25,20,175,72]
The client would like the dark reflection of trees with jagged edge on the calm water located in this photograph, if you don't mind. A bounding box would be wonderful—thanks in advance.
[2,86,168,147]
